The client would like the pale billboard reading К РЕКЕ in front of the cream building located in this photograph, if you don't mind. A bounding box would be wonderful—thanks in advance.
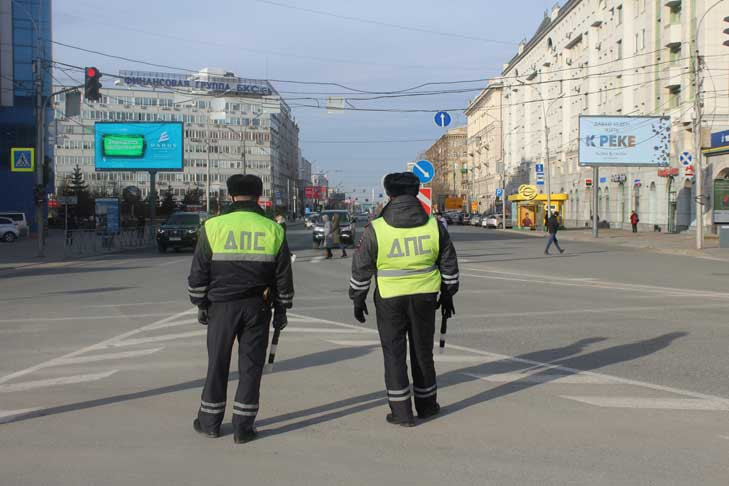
[579,116,671,167]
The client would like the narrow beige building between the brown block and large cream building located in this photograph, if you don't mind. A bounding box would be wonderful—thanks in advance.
[466,82,504,212]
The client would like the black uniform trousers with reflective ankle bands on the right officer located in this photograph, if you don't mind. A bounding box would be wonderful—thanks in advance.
[375,292,438,419]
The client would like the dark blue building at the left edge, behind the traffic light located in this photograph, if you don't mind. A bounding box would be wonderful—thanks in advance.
[0,0,53,230]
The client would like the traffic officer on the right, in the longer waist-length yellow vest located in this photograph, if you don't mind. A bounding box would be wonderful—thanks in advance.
[349,172,458,427]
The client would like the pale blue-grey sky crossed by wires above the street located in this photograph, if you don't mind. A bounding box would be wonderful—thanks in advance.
[53,0,555,194]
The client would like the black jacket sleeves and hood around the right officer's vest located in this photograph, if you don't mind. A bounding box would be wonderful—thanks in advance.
[349,196,459,302]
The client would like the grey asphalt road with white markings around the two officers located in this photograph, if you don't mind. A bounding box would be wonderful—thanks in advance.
[0,223,729,485]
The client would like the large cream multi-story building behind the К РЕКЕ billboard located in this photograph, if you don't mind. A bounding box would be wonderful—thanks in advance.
[469,0,729,234]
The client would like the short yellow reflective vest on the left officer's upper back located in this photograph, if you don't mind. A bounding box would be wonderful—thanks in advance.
[205,211,285,262]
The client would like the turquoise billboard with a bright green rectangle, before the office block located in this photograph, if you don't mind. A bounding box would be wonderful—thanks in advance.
[94,122,184,171]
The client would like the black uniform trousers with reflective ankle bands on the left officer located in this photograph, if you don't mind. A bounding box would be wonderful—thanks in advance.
[198,296,271,430]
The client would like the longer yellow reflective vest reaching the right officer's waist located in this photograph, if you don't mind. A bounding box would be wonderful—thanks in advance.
[372,218,441,299]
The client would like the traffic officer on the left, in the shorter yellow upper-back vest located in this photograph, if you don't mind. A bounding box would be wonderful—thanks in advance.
[188,175,294,444]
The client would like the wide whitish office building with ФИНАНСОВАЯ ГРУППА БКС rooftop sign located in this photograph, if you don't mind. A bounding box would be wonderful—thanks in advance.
[55,69,300,211]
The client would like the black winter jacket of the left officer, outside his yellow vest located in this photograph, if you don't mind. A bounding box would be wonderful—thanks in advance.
[187,201,294,308]
